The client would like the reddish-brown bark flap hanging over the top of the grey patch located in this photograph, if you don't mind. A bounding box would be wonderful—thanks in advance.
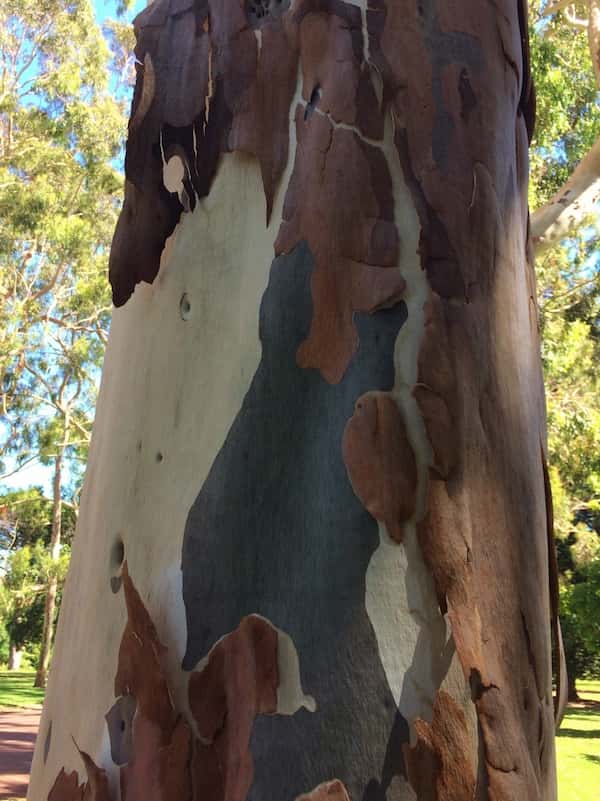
[275,107,405,384]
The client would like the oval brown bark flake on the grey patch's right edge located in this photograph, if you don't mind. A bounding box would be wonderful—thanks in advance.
[342,392,417,542]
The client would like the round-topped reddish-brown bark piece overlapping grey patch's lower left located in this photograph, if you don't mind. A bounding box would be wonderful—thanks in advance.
[189,615,279,801]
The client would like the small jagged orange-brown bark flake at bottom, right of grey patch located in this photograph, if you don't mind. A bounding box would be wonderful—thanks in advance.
[404,690,476,801]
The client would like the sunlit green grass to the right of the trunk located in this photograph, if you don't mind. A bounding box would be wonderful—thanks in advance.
[556,681,600,801]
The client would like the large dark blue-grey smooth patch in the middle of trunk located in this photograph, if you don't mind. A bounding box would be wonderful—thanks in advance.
[182,243,408,801]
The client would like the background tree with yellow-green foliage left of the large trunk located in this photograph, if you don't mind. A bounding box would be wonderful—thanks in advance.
[0,0,131,685]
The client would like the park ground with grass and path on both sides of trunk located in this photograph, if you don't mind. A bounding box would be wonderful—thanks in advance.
[0,672,600,801]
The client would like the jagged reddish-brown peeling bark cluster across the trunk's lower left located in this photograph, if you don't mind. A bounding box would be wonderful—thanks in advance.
[48,563,286,801]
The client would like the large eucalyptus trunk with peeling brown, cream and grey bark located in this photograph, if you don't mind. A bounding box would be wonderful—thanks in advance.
[30,0,556,801]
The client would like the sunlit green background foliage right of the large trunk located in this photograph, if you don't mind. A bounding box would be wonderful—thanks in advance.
[530,2,600,698]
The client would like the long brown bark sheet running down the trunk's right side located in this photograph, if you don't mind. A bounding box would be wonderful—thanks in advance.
[368,0,552,801]
